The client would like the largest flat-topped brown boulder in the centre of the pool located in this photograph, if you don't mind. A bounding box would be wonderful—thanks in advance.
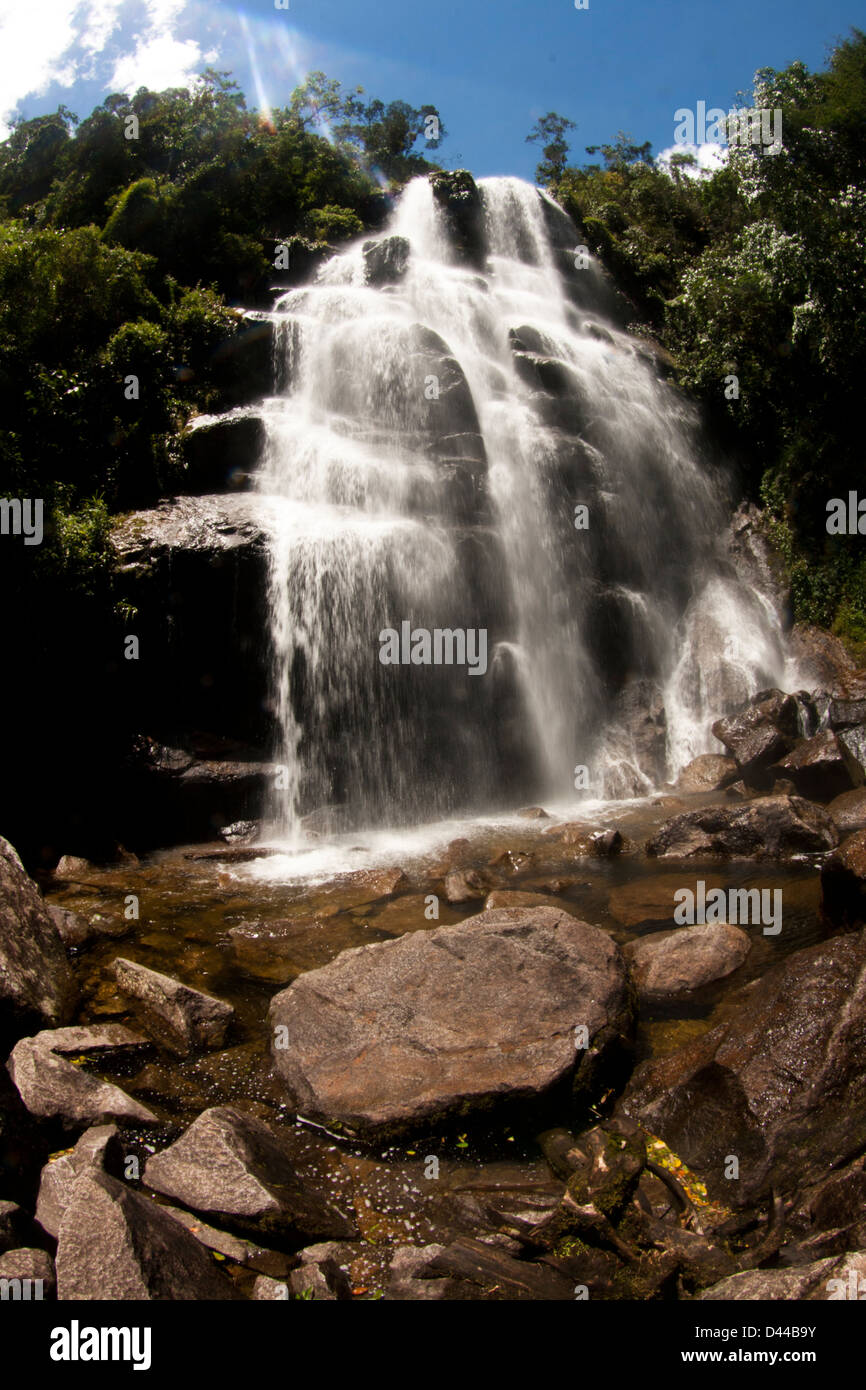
[270,908,631,1136]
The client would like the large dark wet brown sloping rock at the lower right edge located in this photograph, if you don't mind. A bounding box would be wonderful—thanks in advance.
[619,933,866,1207]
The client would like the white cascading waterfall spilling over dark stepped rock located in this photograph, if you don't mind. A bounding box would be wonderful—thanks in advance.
[257,179,784,835]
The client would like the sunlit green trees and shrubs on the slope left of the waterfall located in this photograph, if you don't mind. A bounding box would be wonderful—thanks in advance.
[0,70,445,516]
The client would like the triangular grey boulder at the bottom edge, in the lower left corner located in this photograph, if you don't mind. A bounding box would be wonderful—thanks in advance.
[57,1172,239,1302]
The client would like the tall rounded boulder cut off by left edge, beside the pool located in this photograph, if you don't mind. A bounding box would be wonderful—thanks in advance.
[0,838,72,1037]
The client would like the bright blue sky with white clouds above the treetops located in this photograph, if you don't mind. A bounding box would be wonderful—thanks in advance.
[0,0,866,178]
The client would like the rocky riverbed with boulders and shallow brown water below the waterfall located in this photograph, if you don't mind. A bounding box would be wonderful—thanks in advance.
[0,656,866,1300]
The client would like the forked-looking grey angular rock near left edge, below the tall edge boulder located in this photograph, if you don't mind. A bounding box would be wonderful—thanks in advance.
[6,1023,156,1129]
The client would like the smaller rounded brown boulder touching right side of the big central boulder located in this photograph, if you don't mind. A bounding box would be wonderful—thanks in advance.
[624,922,752,1004]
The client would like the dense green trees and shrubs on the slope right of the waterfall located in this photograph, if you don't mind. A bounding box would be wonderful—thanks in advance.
[539,31,866,646]
